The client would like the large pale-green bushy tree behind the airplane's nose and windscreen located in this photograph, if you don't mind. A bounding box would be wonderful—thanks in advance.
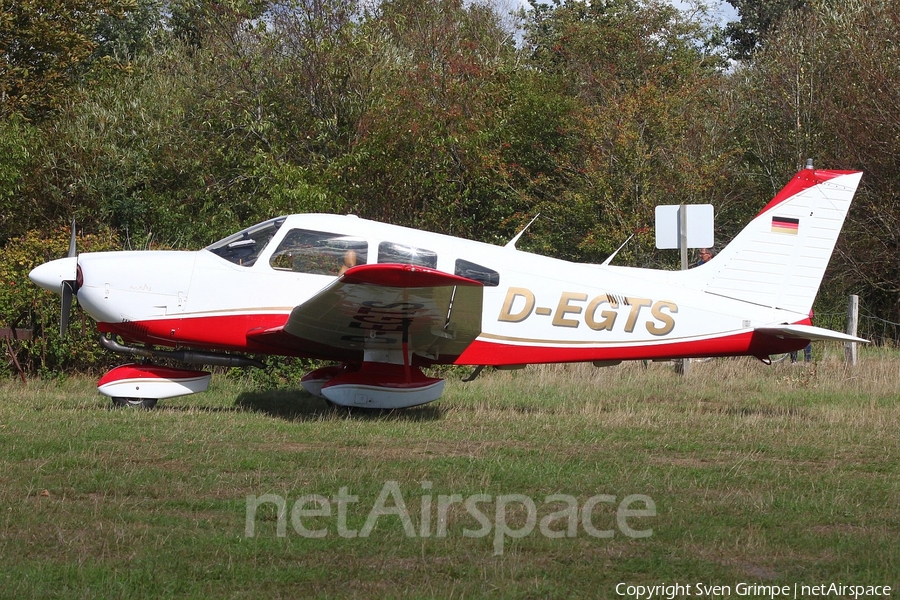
[24,1,364,247]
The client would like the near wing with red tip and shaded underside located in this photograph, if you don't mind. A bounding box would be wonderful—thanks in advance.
[248,264,484,362]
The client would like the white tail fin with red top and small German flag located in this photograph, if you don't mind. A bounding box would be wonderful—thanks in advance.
[691,169,862,316]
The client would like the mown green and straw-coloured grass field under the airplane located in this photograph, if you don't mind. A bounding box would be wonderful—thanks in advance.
[0,347,900,598]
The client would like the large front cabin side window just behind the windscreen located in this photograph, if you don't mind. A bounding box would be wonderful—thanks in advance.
[269,229,369,275]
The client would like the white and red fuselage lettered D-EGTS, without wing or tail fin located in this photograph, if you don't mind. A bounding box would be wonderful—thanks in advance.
[49,214,807,365]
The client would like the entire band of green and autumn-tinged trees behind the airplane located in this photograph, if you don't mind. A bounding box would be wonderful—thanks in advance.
[0,0,900,378]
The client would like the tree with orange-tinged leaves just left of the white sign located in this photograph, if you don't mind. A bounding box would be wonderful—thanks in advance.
[525,0,736,264]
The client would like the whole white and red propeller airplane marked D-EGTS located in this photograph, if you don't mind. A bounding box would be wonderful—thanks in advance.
[29,165,867,409]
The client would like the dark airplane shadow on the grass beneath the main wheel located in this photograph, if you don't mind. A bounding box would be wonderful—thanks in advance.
[234,389,442,421]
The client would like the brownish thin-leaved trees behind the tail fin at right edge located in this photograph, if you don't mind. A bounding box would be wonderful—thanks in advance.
[737,0,900,321]
